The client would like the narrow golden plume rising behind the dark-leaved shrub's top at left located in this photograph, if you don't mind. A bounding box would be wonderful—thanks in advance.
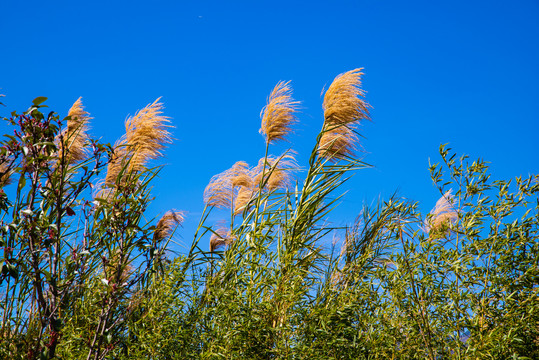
[57,97,92,164]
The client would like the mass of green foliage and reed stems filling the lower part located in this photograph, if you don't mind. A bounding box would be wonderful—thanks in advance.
[0,99,539,359]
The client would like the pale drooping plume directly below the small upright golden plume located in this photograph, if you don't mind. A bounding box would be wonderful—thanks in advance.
[252,154,298,191]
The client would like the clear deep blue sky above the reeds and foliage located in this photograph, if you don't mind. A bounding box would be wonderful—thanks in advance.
[0,0,539,253]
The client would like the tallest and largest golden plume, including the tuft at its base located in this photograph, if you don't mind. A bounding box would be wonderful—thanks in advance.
[318,68,371,162]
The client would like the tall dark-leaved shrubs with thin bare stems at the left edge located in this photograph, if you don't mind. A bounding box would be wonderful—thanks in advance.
[0,97,171,359]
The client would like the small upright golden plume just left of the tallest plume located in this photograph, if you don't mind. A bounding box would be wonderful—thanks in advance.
[259,81,299,143]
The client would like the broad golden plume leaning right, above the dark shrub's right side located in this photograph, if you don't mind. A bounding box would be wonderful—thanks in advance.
[105,98,172,186]
